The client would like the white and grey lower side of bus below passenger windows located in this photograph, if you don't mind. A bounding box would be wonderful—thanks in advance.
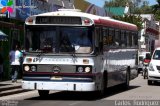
[104,49,138,86]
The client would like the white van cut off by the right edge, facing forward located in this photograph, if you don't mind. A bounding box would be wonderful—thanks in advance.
[148,47,160,85]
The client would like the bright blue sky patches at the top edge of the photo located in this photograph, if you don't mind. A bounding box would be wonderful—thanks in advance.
[86,0,157,7]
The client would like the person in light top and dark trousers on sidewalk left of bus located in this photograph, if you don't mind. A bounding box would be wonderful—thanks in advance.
[9,45,22,82]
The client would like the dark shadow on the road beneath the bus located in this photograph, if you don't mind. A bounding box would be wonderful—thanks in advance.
[28,85,140,101]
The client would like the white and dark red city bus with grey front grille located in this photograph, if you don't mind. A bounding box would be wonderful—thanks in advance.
[22,9,138,96]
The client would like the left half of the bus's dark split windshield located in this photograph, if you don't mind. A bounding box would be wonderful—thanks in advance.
[25,27,56,52]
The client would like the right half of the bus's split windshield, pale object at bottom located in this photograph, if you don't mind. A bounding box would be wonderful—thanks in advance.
[60,27,93,53]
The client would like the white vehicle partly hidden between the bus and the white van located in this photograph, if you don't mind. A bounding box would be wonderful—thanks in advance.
[138,52,151,73]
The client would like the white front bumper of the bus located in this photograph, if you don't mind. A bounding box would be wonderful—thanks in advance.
[22,80,96,91]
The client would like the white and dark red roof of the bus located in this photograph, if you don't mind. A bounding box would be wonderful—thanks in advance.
[27,9,138,31]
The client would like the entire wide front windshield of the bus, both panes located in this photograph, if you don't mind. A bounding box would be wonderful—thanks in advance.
[25,26,93,53]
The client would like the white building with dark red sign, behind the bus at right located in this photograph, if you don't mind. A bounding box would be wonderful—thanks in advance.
[139,14,159,52]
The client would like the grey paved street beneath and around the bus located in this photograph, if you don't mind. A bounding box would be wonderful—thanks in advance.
[0,74,160,106]
